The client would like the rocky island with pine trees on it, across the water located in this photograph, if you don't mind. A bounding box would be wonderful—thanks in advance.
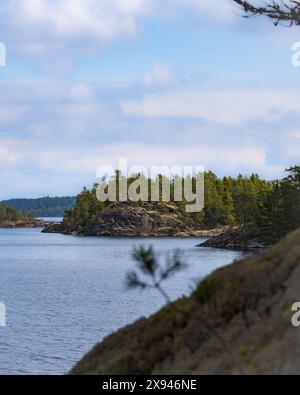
[44,166,300,250]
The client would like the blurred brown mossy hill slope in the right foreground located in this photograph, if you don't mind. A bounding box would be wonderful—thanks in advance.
[71,229,300,374]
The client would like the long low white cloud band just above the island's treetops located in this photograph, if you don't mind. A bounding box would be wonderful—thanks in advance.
[0,140,278,179]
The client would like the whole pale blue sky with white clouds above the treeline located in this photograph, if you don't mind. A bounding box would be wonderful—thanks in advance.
[0,0,300,199]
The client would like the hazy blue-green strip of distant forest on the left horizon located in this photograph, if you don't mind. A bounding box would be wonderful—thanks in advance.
[1,196,76,217]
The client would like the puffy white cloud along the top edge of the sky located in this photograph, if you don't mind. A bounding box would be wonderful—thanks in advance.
[1,0,239,55]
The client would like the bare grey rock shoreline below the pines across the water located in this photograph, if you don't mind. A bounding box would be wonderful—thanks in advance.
[42,203,266,251]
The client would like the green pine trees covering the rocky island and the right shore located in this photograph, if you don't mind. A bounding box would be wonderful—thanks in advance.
[64,166,300,243]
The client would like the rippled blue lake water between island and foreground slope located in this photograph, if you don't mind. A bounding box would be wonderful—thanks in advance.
[0,229,242,374]
